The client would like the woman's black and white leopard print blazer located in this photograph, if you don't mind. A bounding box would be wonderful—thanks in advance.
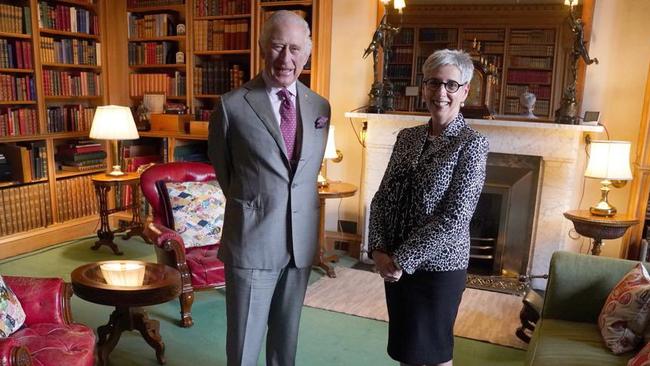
[368,114,489,274]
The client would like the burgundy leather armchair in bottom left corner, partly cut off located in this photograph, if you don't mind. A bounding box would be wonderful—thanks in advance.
[0,276,95,366]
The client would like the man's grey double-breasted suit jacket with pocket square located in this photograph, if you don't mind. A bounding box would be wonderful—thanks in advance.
[208,75,330,269]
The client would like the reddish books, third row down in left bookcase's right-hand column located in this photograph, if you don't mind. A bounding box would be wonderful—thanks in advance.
[43,70,102,96]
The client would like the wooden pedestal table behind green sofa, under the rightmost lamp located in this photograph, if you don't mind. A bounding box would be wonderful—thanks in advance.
[564,210,639,255]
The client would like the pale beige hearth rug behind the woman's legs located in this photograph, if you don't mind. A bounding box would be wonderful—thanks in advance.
[305,267,527,349]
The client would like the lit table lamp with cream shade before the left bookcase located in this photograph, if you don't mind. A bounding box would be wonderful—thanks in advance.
[90,105,140,176]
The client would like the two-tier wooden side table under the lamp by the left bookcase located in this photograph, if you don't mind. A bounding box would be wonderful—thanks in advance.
[91,173,149,255]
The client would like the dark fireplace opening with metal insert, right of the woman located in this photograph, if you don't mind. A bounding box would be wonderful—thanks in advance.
[468,153,542,277]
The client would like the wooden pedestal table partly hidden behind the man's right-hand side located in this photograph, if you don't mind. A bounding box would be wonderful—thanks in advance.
[314,182,357,278]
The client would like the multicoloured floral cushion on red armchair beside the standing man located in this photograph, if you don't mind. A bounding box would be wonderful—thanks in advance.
[166,180,226,248]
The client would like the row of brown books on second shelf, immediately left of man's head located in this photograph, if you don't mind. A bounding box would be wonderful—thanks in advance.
[194,19,250,51]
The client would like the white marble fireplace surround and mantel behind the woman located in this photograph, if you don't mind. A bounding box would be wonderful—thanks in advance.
[345,112,603,287]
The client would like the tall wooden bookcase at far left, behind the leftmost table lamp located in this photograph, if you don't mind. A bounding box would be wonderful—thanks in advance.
[0,0,110,257]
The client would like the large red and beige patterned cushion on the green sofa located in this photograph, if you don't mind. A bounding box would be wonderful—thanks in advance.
[598,263,650,354]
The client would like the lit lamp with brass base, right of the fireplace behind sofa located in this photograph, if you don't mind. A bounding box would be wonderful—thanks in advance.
[585,140,632,216]
